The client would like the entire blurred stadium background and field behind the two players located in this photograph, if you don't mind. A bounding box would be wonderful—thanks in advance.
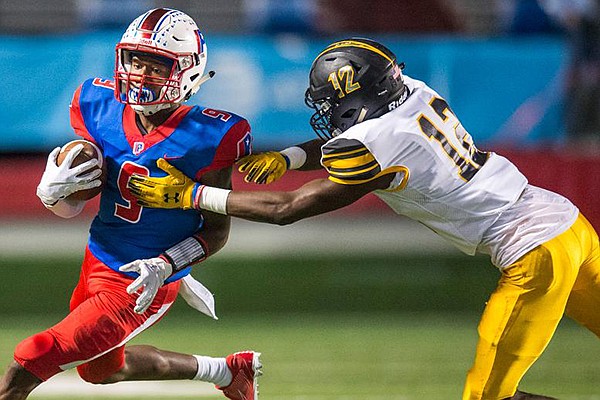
[0,0,600,400]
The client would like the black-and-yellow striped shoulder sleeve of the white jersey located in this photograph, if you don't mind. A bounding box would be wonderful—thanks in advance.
[321,138,381,185]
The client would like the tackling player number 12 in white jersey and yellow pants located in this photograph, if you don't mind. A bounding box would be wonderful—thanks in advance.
[129,39,600,400]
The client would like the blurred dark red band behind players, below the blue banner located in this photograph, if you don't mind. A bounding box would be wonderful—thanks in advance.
[0,149,600,230]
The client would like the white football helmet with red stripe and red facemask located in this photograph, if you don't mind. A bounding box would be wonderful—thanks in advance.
[115,8,214,115]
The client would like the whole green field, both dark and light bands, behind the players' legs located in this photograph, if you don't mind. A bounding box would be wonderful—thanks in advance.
[0,255,600,400]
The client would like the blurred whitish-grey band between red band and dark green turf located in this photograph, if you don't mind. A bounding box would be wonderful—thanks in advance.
[0,215,458,257]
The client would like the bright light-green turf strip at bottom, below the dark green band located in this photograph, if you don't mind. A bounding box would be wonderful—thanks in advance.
[0,313,600,400]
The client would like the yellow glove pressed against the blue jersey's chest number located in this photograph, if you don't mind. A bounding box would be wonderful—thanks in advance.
[127,158,201,210]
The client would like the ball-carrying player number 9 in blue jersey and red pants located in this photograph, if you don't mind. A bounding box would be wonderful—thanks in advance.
[0,8,261,400]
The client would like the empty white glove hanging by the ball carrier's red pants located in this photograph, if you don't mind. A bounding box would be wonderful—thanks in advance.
[119,257,173,314]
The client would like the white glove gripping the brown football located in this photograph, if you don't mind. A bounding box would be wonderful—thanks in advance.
[36,144,102,205]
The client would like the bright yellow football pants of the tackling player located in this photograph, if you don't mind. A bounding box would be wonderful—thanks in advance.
[462,214,600,400]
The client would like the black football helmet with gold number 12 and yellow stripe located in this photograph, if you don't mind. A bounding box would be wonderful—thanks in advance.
[304,38,406,140]
